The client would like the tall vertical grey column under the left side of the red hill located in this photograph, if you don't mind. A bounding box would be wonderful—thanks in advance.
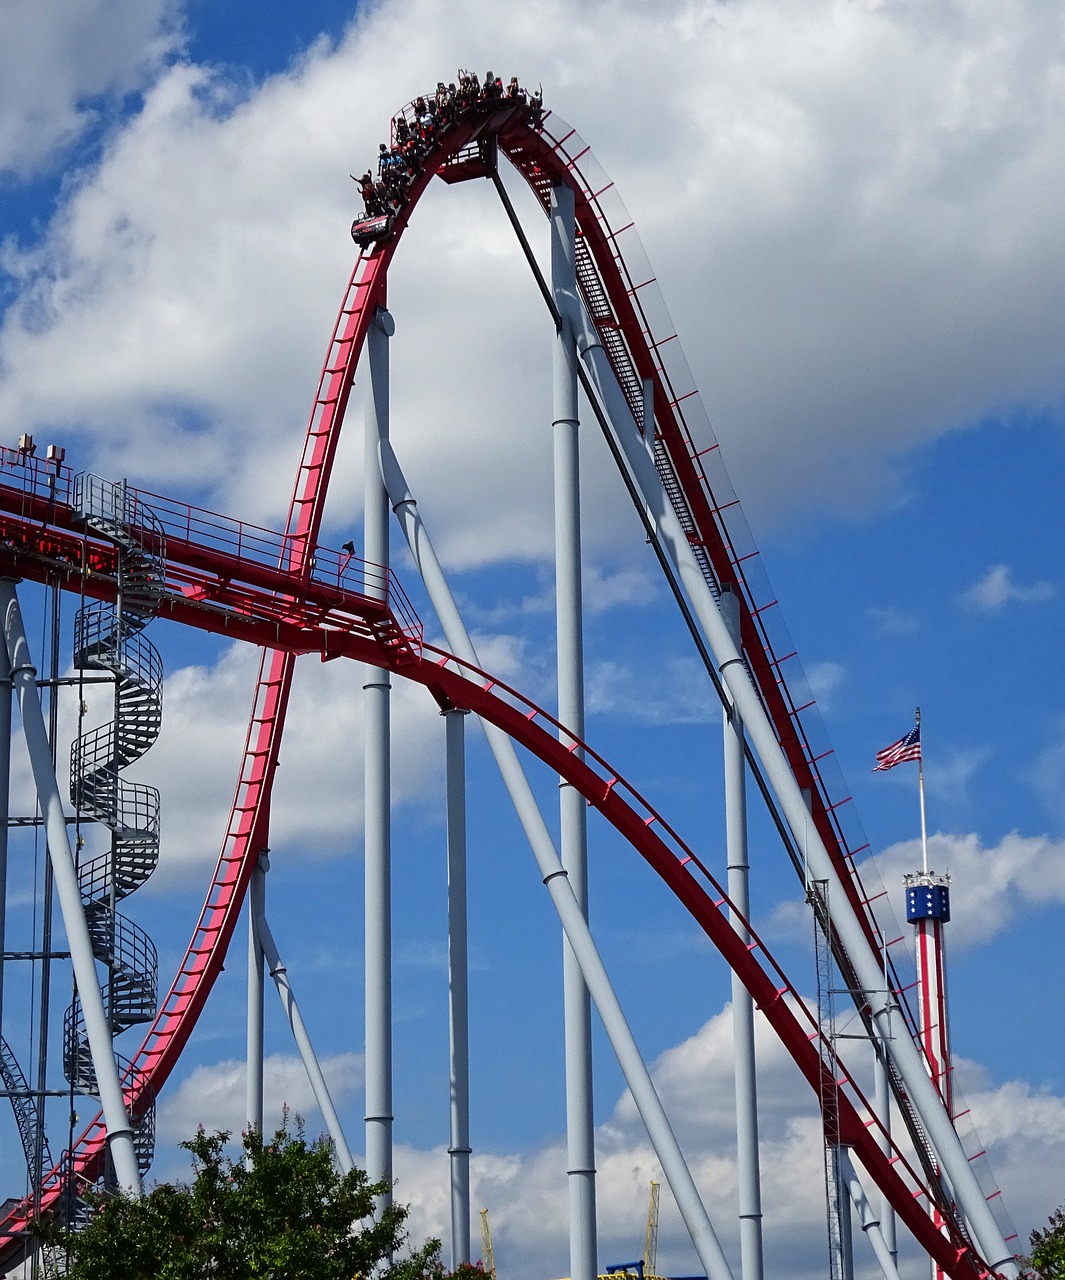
[362,307,396,1208]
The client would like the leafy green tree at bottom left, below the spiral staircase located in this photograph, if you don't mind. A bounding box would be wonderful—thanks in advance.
[36,1116,444,1280]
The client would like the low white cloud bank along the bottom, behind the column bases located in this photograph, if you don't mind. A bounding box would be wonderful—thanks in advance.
[396,1009,1065,1280]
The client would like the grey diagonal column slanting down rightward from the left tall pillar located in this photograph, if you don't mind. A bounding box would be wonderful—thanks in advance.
[380,440,733,1280]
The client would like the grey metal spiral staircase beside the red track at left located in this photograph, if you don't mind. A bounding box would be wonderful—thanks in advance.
[63,474,165,1172]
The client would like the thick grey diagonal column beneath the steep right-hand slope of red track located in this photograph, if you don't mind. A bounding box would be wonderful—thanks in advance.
[577,314,1018,1277]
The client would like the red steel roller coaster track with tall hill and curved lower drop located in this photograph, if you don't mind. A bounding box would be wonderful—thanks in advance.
[0,92,987,1280]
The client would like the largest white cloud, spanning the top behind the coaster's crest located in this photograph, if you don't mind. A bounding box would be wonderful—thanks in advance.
[0,0,1065,564]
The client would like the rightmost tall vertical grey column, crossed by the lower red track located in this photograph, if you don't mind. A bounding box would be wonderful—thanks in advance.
[721,591,764,1280]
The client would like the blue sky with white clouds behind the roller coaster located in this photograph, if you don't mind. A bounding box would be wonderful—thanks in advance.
[0,0,1065,1280]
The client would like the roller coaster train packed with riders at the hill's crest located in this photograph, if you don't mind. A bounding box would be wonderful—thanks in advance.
[351,69,544,248]
